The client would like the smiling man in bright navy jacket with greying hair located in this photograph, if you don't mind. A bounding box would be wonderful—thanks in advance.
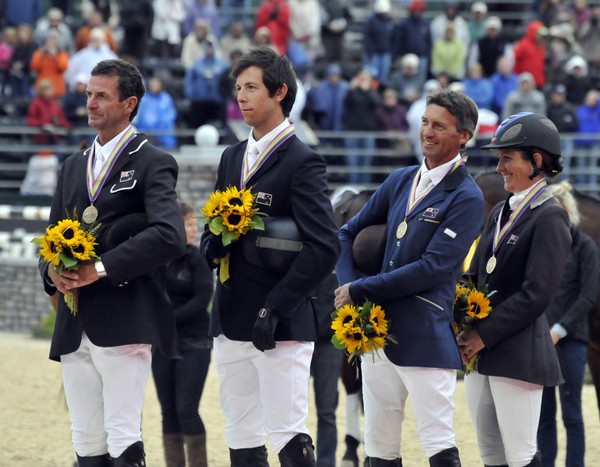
[335,91,483,467]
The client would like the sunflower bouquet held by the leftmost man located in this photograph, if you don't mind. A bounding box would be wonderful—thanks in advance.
[32,212,100,316]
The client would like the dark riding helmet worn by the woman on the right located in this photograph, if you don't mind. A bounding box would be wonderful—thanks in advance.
[481,112,563,176]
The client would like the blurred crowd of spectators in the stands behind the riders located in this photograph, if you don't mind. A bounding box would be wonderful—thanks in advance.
[0,0,600,183]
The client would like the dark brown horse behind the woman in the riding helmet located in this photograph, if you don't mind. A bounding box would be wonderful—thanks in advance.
[476,172,600,410]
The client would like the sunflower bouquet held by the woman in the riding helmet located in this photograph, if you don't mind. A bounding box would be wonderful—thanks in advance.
[453,281,496,374]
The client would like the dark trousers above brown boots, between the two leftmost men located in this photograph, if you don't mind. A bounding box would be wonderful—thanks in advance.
[152,336,212,436]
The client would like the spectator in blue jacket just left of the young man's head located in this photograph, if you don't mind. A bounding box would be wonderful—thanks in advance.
[184,42,229,128]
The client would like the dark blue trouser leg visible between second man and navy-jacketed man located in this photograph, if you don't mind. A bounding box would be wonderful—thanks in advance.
[310,338,342,467]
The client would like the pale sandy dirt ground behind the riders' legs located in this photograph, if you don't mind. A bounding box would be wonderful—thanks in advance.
[0,333,600,467]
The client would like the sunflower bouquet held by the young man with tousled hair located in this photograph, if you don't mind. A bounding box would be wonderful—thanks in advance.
[202,186,265,284]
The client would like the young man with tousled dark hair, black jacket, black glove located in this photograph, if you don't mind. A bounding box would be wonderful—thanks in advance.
[201,48,339,467]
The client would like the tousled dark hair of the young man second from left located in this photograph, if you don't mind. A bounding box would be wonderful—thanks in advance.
[230,47,298,117]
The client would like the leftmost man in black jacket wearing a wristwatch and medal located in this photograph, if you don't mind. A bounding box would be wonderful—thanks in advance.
[40,60,186,467]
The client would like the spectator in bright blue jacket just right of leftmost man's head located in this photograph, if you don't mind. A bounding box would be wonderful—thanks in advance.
[134,76,177,149]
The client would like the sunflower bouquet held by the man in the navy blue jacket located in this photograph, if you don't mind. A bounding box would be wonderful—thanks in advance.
[331,300,397,363]
